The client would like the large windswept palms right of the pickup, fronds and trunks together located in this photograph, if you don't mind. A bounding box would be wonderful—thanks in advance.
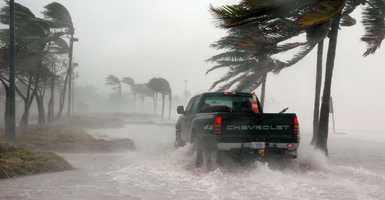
[207,0,385,155]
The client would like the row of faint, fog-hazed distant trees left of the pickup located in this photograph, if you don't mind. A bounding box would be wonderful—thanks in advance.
[106,75,172,119]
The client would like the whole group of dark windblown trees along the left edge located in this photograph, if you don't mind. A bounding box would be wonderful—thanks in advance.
[0,1,77,132]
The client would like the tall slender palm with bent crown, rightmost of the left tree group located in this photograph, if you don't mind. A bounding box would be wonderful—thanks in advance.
[43,2,78,117]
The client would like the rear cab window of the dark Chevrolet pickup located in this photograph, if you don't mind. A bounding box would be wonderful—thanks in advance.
[199,95,253,113]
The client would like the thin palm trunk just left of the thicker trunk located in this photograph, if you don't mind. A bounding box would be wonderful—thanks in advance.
[311,40,324,145]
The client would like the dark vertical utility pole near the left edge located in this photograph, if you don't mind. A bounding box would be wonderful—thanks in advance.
[7,0,16,144]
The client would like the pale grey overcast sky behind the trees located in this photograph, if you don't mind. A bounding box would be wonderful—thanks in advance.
[2,0,385,130]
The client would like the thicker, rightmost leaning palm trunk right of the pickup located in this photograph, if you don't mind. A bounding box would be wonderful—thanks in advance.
[316,15,341,155]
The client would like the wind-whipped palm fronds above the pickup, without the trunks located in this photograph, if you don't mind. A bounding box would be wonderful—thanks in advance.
[207,0,385,91]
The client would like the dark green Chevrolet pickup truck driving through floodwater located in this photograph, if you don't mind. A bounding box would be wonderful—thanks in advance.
[175,92,299,167]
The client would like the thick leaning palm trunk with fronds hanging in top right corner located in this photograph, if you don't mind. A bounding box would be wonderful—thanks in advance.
[315,0,385,155]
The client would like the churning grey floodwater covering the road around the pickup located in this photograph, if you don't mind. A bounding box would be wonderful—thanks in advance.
[0,124,385,200]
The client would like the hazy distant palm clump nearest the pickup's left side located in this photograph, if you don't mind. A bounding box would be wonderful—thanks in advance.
[147,78,172,119]
